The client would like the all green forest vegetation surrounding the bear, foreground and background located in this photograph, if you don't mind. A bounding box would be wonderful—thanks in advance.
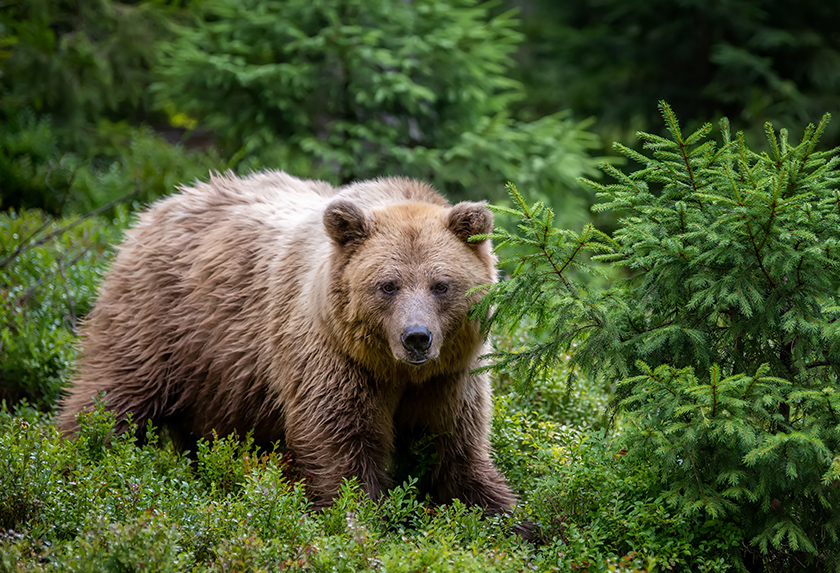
[0,0,840,573]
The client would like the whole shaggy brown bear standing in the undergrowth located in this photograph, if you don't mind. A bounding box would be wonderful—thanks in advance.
[59,172,514,512]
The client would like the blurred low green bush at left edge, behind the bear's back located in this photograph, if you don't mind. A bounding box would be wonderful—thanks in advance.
[0,110,225,215]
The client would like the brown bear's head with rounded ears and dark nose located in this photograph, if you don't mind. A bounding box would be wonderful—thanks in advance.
[324,193,496,381]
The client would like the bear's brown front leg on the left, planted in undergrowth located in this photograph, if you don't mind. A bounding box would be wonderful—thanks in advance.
[286,370,394,508]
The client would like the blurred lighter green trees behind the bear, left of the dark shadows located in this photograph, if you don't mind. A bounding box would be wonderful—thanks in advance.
[0,0,599,221]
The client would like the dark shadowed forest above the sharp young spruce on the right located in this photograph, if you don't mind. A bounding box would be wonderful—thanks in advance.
[505,0,840,150]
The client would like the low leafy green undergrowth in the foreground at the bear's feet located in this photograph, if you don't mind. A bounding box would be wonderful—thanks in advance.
[0,398,738,572]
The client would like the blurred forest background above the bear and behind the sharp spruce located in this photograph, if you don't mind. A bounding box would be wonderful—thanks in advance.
[0,0,840,219]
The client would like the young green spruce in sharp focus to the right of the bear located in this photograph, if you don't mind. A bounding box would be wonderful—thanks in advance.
[477,104,840,570]
